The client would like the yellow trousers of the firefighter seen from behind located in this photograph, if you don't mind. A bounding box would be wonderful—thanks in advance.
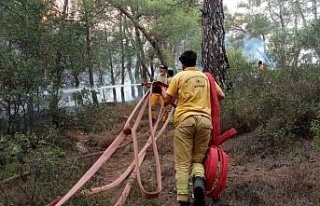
[173,115,212,202]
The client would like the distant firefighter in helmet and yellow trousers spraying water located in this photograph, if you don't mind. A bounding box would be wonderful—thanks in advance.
[151,64,169,122]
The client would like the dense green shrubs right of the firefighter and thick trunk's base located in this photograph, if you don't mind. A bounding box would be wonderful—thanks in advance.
[221,50,320,145]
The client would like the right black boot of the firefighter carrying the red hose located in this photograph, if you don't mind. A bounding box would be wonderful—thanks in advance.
[193,177,206,206]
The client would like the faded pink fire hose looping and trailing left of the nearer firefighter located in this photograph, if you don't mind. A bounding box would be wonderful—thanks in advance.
[47,83,173,206]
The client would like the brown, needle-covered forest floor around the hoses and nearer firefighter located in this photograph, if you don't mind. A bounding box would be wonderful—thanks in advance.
[65,106,320,206]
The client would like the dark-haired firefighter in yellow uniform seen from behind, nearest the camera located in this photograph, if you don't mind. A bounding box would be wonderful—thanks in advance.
[161,50,224,206]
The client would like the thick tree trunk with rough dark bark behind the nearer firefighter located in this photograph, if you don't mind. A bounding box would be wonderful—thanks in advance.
[202,0,229,86]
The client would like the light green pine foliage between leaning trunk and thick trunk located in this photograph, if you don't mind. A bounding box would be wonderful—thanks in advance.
[111,0,201,66]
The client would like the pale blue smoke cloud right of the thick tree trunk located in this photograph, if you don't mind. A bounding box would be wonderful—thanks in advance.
[242,35,276,68]
